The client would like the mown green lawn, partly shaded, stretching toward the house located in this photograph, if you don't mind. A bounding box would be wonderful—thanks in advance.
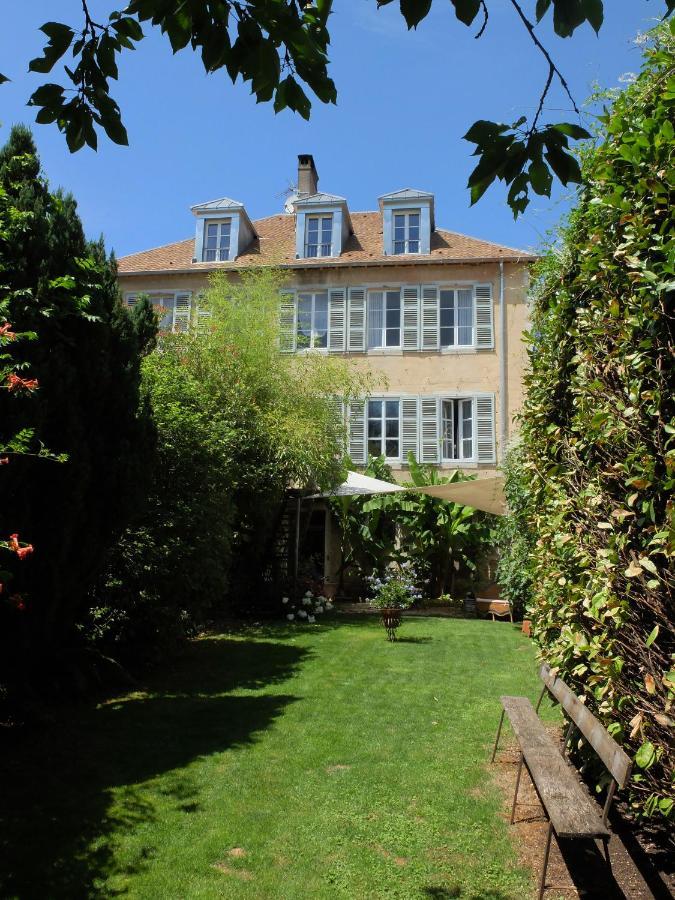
[0,617,556,900]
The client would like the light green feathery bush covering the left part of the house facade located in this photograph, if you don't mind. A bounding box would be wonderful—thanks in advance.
[88,270,367,663]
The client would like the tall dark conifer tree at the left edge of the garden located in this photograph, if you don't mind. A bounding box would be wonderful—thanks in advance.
[0,126,154,681]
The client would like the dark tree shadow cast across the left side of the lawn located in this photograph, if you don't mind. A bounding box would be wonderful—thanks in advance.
[0,637,308,900]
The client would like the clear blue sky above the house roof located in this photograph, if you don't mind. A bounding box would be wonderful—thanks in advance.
[0,0,664,255]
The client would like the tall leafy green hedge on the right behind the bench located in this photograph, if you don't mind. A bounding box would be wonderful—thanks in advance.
[505,27,675,816]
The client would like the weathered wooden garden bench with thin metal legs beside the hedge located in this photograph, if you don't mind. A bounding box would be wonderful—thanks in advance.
[492,664,632,900]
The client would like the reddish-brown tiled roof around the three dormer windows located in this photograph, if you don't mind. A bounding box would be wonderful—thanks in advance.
[118,212,536,275]
